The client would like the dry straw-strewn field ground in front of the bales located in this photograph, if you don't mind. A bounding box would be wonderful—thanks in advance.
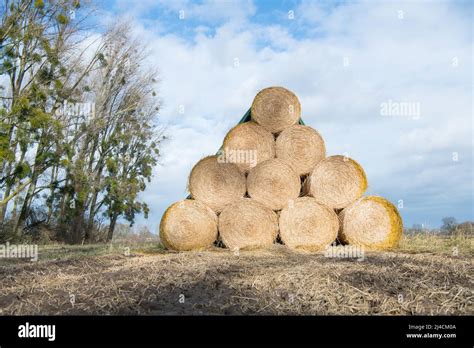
[0,236,474,315]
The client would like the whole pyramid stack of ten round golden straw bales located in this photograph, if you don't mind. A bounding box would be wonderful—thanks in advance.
[160,87,402,251]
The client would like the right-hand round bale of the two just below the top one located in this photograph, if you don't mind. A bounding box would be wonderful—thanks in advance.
[275,124,326,175]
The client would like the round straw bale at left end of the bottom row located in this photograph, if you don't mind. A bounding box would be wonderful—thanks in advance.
[160,199,217,251]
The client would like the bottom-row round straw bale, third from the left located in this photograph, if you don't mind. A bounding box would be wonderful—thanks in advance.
[280,197,339,251]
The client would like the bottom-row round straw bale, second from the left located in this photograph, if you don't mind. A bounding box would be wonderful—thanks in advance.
[219,198,278,249]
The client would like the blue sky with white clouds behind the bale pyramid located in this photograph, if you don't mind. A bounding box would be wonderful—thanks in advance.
[94,0,474,231]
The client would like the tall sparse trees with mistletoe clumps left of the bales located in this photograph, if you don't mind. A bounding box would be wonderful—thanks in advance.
[0,0,164,243]
